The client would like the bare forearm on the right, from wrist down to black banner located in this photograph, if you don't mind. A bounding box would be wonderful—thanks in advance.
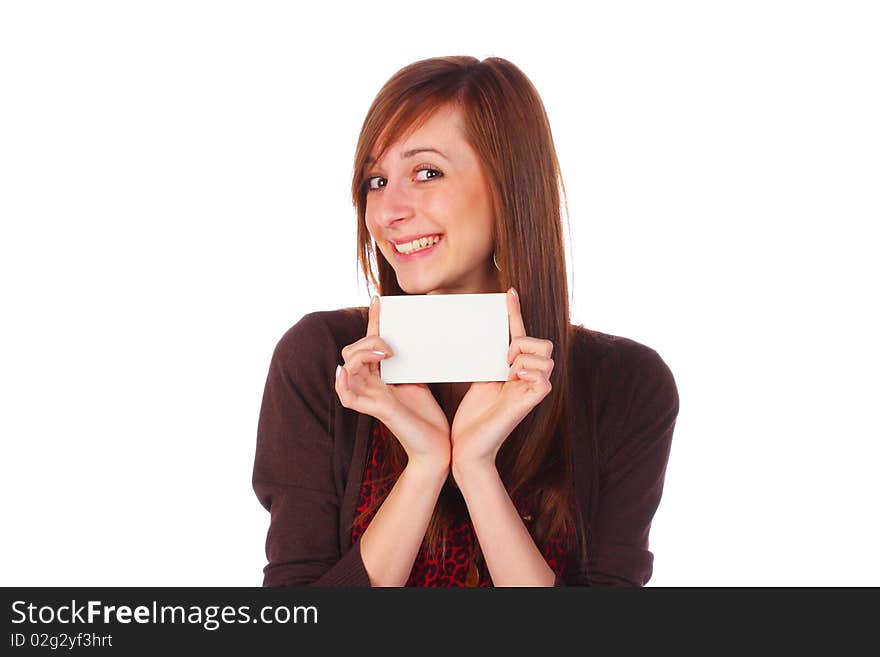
[453,458,557,586]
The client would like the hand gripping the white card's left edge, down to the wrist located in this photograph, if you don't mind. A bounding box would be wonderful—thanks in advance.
[336,297,451,467]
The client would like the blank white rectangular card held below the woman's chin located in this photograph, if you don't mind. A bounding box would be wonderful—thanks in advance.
[379,292,510,383]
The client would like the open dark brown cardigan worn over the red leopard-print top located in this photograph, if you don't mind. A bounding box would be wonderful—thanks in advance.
[253,307,678,586]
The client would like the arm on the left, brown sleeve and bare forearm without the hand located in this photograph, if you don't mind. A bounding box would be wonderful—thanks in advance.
[253,314,448,586]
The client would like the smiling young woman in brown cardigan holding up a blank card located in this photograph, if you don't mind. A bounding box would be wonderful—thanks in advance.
[253,57,678,586]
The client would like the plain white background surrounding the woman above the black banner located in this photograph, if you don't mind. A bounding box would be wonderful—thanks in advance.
[0,0,880,586]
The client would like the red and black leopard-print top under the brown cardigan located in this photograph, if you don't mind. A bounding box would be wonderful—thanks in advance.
[351,420,567,587]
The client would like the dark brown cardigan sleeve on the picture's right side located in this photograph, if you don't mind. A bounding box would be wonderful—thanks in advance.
[572,342,679,586]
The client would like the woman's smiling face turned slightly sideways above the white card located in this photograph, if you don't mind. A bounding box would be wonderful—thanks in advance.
[365,106,500,294]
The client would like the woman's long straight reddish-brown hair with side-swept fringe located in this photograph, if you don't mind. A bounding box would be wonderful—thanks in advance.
[351,56,587,576]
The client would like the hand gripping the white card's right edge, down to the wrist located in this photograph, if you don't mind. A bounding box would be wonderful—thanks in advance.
[450,288,553,468]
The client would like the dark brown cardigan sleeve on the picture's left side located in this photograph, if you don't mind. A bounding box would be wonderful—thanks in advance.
[252,313,371,587]
